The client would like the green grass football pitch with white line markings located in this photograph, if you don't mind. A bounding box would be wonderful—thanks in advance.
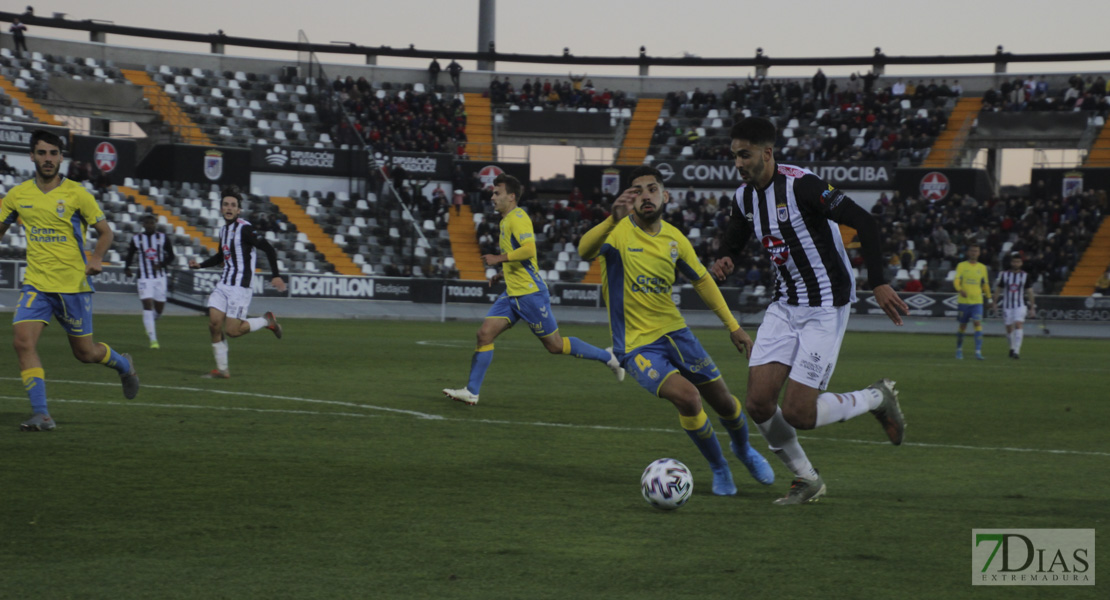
[0,316,1110,599]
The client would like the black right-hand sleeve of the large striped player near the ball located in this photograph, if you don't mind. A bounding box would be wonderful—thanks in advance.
[794,175,887,289]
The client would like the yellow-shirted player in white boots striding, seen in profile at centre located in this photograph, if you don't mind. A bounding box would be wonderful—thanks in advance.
[443,173,625,405]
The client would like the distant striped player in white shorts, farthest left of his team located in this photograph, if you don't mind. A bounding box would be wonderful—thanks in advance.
[123,213,173,349]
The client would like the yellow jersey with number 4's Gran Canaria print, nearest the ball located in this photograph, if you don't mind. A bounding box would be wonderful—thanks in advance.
[598,215,706,354]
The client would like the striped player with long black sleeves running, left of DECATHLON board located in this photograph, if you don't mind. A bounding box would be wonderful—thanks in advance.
[189,185,285,379]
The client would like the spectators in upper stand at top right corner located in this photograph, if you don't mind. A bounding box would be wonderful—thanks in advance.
[982,74,1110,115]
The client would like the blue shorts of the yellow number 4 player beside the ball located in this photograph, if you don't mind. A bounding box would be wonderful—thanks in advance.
[617,327,720,396]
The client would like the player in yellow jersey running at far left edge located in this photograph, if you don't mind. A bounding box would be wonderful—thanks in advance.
[0,130,139,431]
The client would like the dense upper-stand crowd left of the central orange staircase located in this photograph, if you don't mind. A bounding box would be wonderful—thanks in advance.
[321,77,466,157]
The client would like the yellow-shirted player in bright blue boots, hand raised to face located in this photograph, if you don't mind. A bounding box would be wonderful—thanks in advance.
[578,166,775,496]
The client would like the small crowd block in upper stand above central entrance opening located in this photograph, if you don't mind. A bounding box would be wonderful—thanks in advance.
[490,74,634,110]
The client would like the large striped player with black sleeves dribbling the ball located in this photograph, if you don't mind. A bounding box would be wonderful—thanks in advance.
[713,118,909,505]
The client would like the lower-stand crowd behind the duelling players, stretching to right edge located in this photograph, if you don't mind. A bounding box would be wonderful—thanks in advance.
[457,170,1108,294]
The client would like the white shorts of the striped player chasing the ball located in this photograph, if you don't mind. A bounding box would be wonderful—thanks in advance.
[748,302,851,389]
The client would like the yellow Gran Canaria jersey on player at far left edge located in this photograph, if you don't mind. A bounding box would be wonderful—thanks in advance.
[0,179,104,294]
